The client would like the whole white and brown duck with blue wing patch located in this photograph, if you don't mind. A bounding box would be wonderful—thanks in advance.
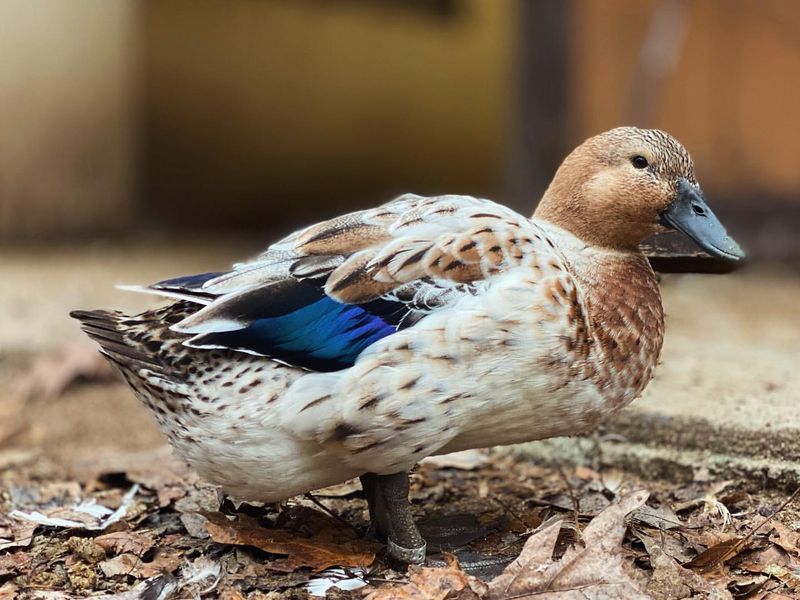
[71,127,744,564]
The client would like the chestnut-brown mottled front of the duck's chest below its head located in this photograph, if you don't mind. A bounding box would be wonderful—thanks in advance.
[574,250,664,404]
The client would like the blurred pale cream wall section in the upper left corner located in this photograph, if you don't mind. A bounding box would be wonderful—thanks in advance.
[0,0,136,241]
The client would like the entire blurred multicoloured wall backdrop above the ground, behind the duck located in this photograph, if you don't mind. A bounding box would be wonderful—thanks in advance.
[0,0,800,248]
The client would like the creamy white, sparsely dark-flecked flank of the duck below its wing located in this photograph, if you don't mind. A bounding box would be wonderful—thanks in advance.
[281,264,620,473]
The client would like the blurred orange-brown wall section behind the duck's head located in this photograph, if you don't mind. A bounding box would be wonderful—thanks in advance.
[569,0,800,206]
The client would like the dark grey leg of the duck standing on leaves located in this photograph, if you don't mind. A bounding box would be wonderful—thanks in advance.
[373,472,425,565]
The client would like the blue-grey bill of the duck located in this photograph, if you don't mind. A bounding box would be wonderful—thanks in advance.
[661,179,744,260]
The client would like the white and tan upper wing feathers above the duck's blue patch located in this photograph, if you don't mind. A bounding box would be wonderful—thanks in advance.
[196,194,539,304]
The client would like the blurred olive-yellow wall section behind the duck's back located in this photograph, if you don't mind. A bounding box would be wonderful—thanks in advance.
[143,0,516,228]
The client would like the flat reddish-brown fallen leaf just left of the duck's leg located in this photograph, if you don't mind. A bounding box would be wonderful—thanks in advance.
[201,511,380,571]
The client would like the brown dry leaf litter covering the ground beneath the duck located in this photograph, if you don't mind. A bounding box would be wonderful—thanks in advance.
[0,440,800,600]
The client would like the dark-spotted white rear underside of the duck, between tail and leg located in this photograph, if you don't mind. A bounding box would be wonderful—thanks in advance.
[134,357,361,502]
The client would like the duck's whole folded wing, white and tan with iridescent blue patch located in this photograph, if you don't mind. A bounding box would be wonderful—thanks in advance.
[154,195,545,371]
